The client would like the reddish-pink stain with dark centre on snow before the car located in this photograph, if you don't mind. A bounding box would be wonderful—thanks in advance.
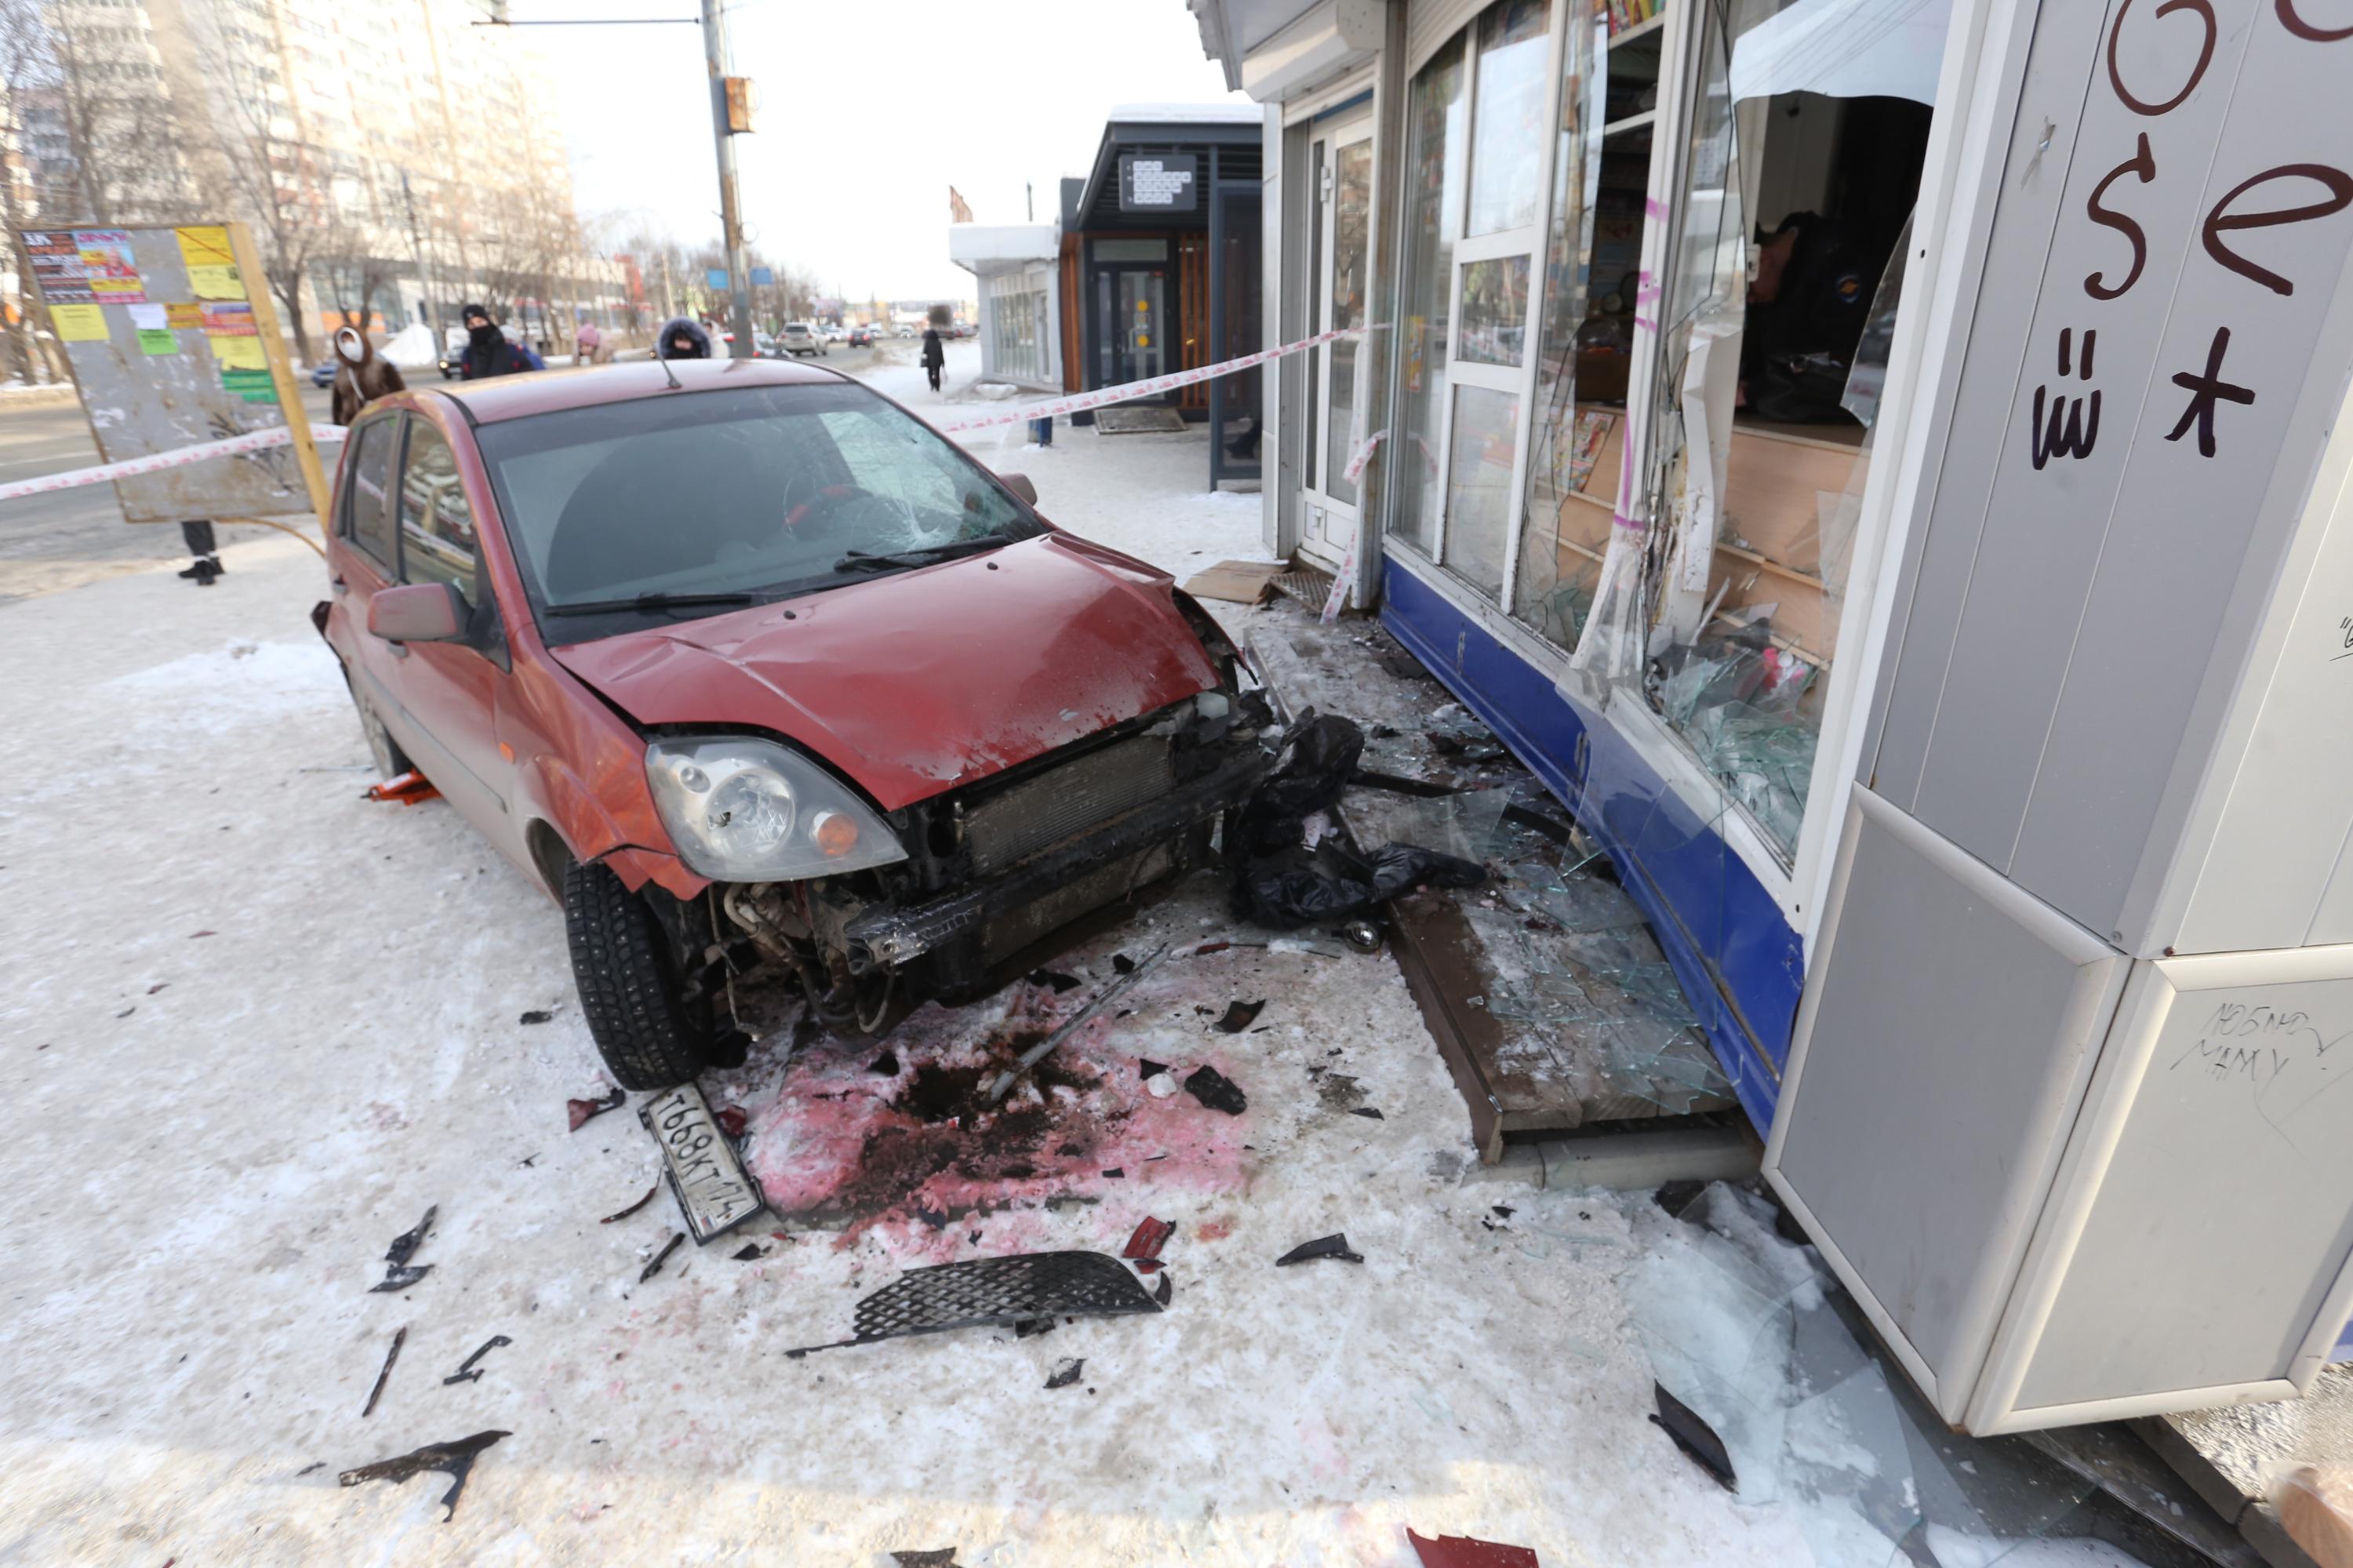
[746,984,1252,1255]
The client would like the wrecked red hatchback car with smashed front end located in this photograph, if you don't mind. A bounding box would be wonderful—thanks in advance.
[315,360,1266,1088]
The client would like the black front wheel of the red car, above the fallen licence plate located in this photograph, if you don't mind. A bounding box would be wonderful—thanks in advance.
[565,862,713,1090]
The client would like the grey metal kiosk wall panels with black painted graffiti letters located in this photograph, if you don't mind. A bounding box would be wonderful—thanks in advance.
[1767,0,2353,1434]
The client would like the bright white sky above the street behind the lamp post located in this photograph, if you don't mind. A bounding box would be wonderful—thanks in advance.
[511,0,1247,299]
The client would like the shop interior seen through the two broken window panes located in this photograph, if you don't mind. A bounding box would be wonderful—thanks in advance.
[1515,0,1939,860]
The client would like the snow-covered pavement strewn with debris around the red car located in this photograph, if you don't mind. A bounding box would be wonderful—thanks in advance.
[0,346,2155,1568]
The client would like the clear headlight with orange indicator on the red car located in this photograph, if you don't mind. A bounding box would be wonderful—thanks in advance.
[645,734,906,883]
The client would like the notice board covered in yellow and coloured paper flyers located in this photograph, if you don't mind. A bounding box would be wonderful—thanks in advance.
[24,224,327,522]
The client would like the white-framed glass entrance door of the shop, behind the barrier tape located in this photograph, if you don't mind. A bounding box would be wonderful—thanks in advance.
[1299,118,1372,567]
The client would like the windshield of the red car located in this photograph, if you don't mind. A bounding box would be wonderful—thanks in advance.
[475,384,1042,621]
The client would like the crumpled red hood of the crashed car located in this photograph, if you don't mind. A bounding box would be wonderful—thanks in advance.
[551,534,1219,810]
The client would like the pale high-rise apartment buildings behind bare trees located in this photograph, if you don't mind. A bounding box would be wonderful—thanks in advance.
[0,0,628,353]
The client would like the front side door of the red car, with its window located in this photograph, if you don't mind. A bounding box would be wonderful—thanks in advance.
[379,414,515,848]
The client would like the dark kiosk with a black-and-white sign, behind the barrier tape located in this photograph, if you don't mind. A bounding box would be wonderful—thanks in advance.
[1061,104,1264,487]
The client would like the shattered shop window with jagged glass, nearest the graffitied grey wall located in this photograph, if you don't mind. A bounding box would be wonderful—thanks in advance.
[1577,2,1927,862]
